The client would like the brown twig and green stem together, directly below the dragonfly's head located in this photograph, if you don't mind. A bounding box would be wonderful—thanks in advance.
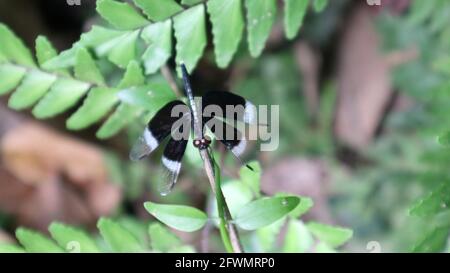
[200,149,243,253]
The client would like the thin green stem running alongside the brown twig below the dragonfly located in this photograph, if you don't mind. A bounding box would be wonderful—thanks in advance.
[211,152,234,253]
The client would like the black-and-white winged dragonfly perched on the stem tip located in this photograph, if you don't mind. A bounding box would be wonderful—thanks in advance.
[130,64,256,195]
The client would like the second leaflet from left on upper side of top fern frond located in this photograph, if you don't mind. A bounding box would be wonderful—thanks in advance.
[134,0,183,21]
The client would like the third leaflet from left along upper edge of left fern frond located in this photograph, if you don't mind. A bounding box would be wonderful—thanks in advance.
[74,47,105,85]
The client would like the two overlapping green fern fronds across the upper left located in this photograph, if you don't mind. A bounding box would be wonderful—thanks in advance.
[0,0,326,138]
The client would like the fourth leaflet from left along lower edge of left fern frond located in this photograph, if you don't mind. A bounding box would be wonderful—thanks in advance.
[66,87,119,130]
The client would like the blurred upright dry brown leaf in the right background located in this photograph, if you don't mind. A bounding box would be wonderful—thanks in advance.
[335,5,392,150]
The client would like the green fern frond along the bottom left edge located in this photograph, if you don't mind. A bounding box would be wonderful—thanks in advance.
[0,218,194,253]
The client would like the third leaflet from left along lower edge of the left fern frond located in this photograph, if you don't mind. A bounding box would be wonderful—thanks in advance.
[33,78,90,118]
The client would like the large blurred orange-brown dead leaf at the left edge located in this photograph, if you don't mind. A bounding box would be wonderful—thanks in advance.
[0,122,121,230]
